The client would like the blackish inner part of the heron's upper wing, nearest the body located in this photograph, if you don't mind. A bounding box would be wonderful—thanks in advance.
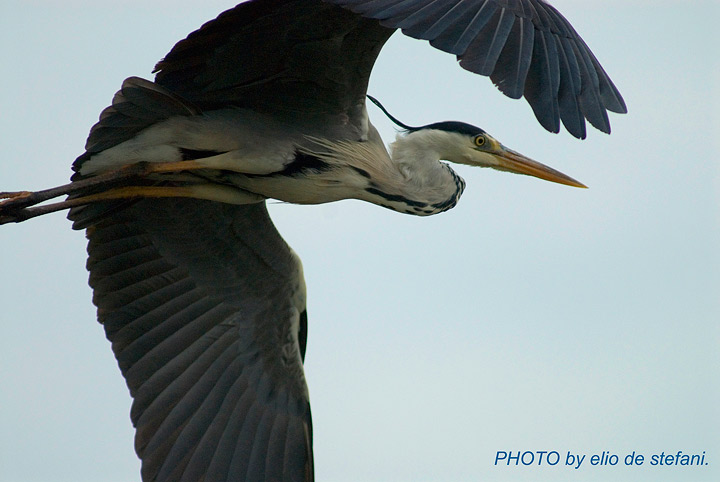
[155,0,394,122]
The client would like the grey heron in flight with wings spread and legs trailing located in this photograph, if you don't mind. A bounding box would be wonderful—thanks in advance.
[0,0,627,482]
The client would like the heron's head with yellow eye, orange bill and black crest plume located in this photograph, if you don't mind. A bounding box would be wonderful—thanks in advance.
[368,96,587,188]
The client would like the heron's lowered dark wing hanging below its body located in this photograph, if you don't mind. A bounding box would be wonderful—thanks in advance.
[70,199,313,482]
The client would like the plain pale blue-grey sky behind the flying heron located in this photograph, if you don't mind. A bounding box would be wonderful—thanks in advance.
[0,0,720,482]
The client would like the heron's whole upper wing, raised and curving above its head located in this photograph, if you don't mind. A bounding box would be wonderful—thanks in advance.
[156,0,627,138]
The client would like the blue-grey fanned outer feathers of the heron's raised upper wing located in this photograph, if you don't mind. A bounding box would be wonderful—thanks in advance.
[326,0,627,138]
